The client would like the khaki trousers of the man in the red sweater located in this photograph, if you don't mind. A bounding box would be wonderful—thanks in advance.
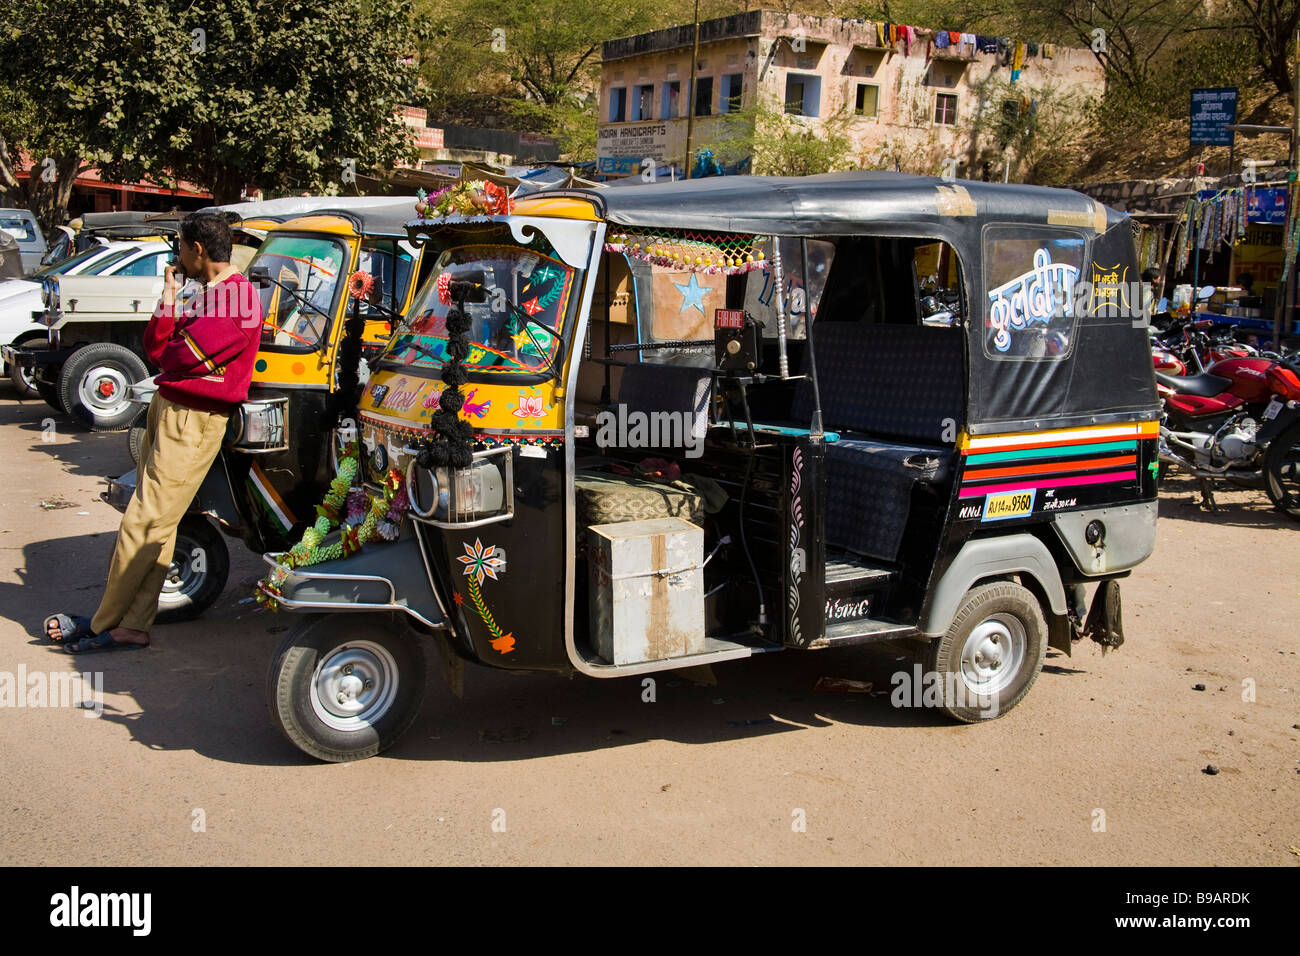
[91,393,230,633]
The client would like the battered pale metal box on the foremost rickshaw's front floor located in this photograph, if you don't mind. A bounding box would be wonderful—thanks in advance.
[586,518,705,665]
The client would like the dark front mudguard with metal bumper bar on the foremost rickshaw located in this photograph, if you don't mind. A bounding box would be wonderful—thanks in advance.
[257,535,446,628]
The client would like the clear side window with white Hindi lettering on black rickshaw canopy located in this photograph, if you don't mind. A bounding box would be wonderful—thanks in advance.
[984,226,1087,360]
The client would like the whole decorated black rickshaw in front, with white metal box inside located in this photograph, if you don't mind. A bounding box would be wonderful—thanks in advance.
[259,173,1160,761]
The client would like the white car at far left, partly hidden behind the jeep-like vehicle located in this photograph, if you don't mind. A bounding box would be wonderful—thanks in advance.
[0,247,172,398]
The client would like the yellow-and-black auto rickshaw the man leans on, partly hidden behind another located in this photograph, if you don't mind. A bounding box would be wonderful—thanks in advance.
[103,199,434,623]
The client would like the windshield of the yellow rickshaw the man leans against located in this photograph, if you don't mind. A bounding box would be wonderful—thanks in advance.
[250,235,347,351]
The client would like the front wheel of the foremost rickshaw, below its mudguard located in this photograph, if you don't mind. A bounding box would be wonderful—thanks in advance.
[267,614,425,763]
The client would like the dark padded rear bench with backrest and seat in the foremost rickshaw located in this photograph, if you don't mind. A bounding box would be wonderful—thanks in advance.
[792,323,966,562]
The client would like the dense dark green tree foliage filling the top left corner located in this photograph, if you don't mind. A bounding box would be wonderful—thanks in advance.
[0,0,416,228]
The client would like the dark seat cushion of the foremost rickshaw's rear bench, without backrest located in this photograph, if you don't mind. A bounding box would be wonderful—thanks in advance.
[826,436,953,562]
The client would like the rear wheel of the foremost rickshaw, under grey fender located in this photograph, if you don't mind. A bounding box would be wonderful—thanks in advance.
[926,581,1048,723]
